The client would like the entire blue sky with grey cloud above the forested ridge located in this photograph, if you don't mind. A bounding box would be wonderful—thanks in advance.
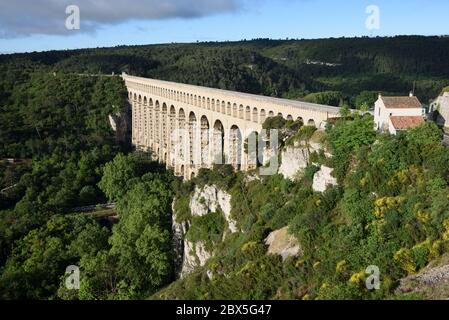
[0,0,449,52]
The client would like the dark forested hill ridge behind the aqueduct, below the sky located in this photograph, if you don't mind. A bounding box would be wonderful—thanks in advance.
[0,36,449,106]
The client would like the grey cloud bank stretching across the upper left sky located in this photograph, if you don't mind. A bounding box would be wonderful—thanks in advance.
[0,0,241,38]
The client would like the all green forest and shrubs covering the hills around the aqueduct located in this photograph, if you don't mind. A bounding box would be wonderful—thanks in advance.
[0,37,449,299]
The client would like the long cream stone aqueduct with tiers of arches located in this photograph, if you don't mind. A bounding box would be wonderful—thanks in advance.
[122,74,339,179]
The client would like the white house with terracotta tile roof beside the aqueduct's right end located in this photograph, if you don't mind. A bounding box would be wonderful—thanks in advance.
[374,94,425,134]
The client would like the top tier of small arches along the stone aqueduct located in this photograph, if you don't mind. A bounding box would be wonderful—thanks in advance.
[124,76,339,126]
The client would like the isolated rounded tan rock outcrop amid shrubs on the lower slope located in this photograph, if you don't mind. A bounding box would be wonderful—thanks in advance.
[265,227,301,260]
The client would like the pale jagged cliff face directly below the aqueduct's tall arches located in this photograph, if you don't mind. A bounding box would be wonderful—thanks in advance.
[190,185,237,233]
